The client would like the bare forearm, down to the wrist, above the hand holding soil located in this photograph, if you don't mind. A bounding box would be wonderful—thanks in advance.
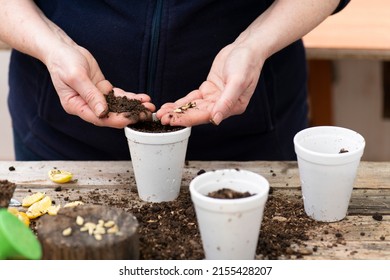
[0,0,74,63]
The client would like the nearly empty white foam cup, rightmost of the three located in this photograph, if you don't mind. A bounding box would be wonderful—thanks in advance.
[294,126,365,222]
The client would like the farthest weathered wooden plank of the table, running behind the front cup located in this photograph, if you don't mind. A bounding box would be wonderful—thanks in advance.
[0,161,390,189]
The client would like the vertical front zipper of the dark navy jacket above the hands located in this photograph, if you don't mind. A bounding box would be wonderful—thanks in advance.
[146,0,163,99]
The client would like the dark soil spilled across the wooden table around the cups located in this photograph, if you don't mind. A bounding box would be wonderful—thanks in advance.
[26,166,342,260]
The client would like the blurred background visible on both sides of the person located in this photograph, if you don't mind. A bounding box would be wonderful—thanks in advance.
[0,0,390,161]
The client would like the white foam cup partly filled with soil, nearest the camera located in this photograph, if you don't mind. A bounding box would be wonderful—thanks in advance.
[190,169,269,260]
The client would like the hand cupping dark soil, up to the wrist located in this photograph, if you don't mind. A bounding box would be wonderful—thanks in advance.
[45,44,155,128]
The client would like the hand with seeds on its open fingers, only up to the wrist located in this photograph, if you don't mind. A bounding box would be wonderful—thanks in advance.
[156,43,263,126]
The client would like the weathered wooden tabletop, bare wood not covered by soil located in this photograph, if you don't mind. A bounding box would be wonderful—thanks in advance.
[0,161,390,259]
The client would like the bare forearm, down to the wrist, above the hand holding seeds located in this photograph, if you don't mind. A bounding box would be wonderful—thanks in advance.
[235,0,340,60]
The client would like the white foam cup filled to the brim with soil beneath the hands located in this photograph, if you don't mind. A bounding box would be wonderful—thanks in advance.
[125,117,191,202]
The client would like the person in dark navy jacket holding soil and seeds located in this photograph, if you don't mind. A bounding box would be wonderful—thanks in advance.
[0,0,348,160]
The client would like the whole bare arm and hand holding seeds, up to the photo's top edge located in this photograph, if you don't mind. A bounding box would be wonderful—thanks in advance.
[157,0,340,126]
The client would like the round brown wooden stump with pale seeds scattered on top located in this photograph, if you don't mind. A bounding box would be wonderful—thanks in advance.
[37,205,139,260]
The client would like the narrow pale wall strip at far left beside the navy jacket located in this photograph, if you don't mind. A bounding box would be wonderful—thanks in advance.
[0,49,14,160]
